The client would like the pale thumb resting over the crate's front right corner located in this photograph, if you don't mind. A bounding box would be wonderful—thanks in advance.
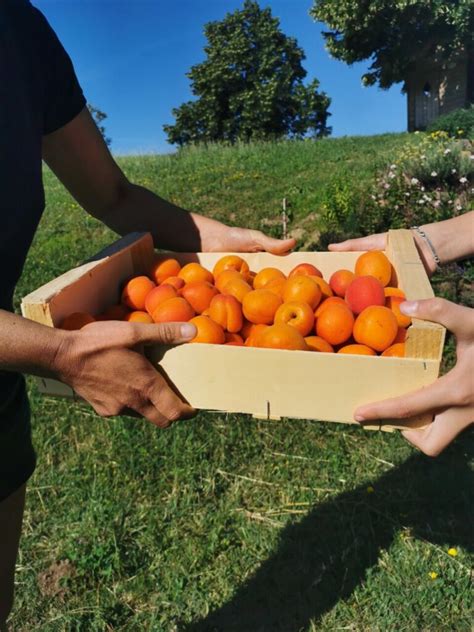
[400,298,473,334]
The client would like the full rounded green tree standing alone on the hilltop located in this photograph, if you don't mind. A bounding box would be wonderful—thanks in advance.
[163,0,331,145]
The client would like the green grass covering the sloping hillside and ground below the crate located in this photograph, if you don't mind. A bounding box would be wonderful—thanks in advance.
[9,135,474,632]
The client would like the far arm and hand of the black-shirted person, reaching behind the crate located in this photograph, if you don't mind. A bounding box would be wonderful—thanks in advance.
[43,108,295,254]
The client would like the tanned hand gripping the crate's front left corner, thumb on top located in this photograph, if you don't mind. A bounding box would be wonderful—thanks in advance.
[52,321,196,428]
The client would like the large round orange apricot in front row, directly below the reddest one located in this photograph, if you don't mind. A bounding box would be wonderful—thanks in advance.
[354,305,398,351]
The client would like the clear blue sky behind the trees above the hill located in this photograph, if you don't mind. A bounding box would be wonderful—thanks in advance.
[32,0,406,154]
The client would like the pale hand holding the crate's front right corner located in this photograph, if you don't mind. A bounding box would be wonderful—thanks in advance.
[354,298,474,456]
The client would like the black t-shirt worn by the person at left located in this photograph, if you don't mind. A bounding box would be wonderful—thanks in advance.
[0,0,85,403]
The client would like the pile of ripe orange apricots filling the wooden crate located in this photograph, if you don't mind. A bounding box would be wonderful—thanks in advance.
[61,251,411,357]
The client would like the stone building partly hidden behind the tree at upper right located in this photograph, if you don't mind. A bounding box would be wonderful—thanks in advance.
[405,53,474,132]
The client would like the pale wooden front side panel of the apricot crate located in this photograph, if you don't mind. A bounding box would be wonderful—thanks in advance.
[149,344,438,427]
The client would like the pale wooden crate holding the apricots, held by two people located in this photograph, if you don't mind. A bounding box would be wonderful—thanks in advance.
[22,230,445,430]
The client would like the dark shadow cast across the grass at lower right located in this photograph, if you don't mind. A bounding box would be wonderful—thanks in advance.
[178,433,474,632]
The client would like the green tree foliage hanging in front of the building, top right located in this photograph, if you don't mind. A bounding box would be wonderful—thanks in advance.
[311,0,474,88]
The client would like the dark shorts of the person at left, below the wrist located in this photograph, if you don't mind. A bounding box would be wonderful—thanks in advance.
[0,372,36,502]
